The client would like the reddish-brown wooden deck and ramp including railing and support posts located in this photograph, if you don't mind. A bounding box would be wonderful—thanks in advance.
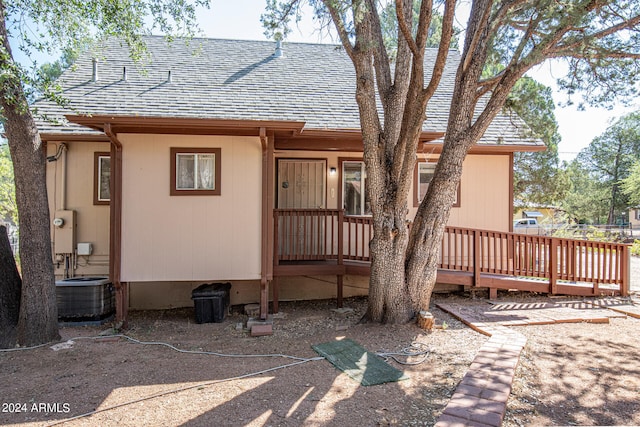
[273,209,630,308]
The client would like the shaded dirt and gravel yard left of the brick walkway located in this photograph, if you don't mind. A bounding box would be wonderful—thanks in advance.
[0,298,487,427]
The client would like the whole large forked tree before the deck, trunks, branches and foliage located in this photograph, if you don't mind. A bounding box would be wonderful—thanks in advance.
[263,0,640,322]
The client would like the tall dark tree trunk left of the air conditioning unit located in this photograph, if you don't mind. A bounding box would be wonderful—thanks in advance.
[0,0,60,345]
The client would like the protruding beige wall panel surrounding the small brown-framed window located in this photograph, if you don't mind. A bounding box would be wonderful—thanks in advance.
[119,135,262,281]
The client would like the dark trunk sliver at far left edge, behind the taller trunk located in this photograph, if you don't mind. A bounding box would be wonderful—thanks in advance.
[0,225,22,348]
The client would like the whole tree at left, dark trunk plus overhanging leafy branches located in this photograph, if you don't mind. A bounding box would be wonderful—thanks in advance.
[0,0,208,345]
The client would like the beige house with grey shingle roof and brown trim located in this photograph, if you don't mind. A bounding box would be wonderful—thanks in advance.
[36,37,544,324]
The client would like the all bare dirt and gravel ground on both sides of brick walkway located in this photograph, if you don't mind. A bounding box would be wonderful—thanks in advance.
[0,264,640,427]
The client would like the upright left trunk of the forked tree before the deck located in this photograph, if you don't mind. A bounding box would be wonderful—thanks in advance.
[342,0,453,323]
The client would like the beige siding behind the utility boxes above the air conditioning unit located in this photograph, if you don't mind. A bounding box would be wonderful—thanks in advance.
[47,142,109,276]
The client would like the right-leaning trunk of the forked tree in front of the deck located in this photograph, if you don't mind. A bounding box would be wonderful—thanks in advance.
[405,0,508,310]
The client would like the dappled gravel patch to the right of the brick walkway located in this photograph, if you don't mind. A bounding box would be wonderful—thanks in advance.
[503,256,640,427]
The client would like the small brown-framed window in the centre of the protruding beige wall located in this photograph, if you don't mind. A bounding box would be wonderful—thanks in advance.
[170,147,221,196]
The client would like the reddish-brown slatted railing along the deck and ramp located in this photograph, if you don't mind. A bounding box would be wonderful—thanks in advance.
[274,209,629,295]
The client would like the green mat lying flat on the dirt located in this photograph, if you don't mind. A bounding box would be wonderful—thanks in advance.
[311,339,408,385]
